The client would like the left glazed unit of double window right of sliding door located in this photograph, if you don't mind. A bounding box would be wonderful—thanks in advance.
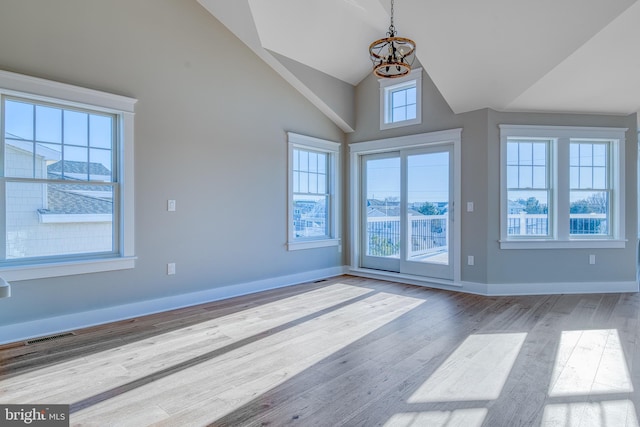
[507,138,551,238]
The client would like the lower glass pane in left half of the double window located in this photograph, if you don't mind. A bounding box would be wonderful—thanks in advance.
[507,191,549,236]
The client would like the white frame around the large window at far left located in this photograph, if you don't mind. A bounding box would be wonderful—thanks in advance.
[0,70,137,281]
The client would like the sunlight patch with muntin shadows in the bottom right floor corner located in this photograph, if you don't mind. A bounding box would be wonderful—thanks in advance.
[541,400,638,427]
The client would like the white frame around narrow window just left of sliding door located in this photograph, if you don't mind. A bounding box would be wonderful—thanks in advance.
[287,132,340,251]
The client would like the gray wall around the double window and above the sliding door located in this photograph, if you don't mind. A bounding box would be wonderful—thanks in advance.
[347,71,638,284]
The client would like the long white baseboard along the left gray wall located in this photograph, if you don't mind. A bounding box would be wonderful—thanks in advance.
[0,267,346,344]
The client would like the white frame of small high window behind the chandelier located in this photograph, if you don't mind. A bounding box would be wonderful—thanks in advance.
[378,68,422,130]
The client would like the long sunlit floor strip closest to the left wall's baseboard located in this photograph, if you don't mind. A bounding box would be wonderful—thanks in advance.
[0,283,373,404]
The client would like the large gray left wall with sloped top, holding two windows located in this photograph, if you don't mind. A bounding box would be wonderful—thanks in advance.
[0,0,344,325]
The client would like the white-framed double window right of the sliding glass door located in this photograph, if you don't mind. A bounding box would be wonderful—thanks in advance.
[500,125,626,249]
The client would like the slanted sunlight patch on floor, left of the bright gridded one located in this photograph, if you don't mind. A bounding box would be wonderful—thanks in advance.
[408,333,527,403]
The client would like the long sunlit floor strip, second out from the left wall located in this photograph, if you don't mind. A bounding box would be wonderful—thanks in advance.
[71,292,425,426]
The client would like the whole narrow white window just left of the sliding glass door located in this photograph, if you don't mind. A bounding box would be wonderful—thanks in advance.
[288,133,340,250]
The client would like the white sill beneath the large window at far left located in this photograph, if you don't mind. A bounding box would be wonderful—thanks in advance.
[0,257,137,282]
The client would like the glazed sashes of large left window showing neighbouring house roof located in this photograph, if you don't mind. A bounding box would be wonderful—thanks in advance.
[0,97,119,263]
